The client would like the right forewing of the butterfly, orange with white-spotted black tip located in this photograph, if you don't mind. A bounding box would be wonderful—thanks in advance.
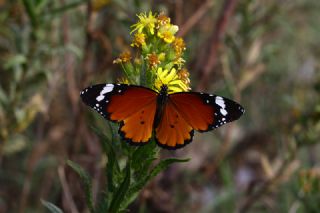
[169,92,244,132]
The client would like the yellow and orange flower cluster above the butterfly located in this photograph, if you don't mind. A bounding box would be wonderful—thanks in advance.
[114,12,190,93]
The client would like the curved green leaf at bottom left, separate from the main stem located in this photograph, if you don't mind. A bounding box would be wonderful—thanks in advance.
[67,160,95,212]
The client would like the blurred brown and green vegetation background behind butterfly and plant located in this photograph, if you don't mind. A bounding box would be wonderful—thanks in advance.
[0,0,320,213]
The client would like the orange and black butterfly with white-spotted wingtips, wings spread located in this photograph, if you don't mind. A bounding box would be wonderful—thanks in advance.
[80,84,244,149]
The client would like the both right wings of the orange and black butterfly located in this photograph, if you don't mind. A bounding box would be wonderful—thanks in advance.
[156,92,244,149]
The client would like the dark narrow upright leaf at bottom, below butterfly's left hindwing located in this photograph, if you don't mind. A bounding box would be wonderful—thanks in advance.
[109,161,131,212]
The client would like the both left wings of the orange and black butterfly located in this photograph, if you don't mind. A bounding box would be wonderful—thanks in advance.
[80,84,157,145]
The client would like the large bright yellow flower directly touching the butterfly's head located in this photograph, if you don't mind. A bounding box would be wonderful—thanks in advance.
[154,67,189,93]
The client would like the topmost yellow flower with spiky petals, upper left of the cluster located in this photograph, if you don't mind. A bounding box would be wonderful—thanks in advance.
[131,11,157,35]
